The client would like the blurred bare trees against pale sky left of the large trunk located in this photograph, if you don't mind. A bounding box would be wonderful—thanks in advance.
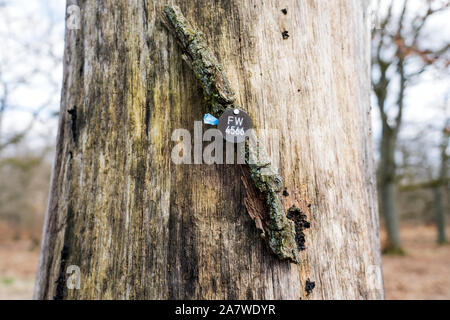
[0,1,64,244]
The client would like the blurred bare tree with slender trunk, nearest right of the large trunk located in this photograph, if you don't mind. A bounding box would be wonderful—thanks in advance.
[372,0,450,254]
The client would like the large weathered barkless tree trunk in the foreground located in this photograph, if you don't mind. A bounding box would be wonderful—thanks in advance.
[35,0,384,299]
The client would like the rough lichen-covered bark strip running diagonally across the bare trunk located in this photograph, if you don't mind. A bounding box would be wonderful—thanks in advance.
[162,6,300,263]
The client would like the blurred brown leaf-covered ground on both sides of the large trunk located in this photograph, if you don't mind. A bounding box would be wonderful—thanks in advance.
[0,225,450,300]
